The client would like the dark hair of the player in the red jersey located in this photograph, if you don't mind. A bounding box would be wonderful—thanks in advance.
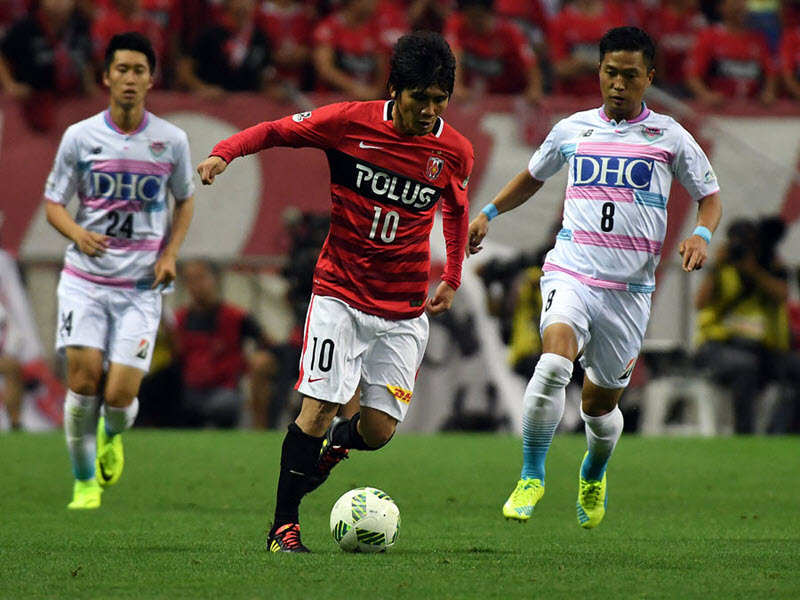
[387,31,456,97]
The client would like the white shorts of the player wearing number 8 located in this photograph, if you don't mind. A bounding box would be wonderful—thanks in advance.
[539,271,651,389]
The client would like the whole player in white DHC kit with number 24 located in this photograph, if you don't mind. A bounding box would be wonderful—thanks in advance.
[44,33,194,509]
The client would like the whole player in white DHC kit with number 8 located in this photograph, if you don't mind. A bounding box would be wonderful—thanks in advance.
[466,27,722,529]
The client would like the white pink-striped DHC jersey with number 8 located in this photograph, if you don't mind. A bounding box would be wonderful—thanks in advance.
[528,103,719,293]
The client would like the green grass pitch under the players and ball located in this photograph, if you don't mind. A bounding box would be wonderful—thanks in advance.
[0,431,800,600]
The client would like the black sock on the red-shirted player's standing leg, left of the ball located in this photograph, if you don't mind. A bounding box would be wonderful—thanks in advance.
[272,423,325,531]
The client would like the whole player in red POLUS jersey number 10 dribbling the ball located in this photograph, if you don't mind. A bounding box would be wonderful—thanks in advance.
[197,31,473,552]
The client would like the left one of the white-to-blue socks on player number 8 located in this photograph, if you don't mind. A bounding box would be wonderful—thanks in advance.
[521,353,572,483]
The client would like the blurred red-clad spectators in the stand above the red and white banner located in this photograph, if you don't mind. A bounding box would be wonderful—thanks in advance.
[6,0,800,127]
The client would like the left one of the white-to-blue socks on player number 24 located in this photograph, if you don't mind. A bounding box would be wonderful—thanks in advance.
[64,390,97,481]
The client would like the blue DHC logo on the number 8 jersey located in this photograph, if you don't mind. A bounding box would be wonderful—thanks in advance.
[572,154,654,190]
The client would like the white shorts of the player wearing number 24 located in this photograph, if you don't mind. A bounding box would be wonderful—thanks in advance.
[56,273,161,372]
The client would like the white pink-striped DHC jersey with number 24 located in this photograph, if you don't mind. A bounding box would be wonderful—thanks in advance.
[44,110,194,289]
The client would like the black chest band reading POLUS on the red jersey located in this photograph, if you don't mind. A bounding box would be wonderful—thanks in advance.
[328,150,442,211]
